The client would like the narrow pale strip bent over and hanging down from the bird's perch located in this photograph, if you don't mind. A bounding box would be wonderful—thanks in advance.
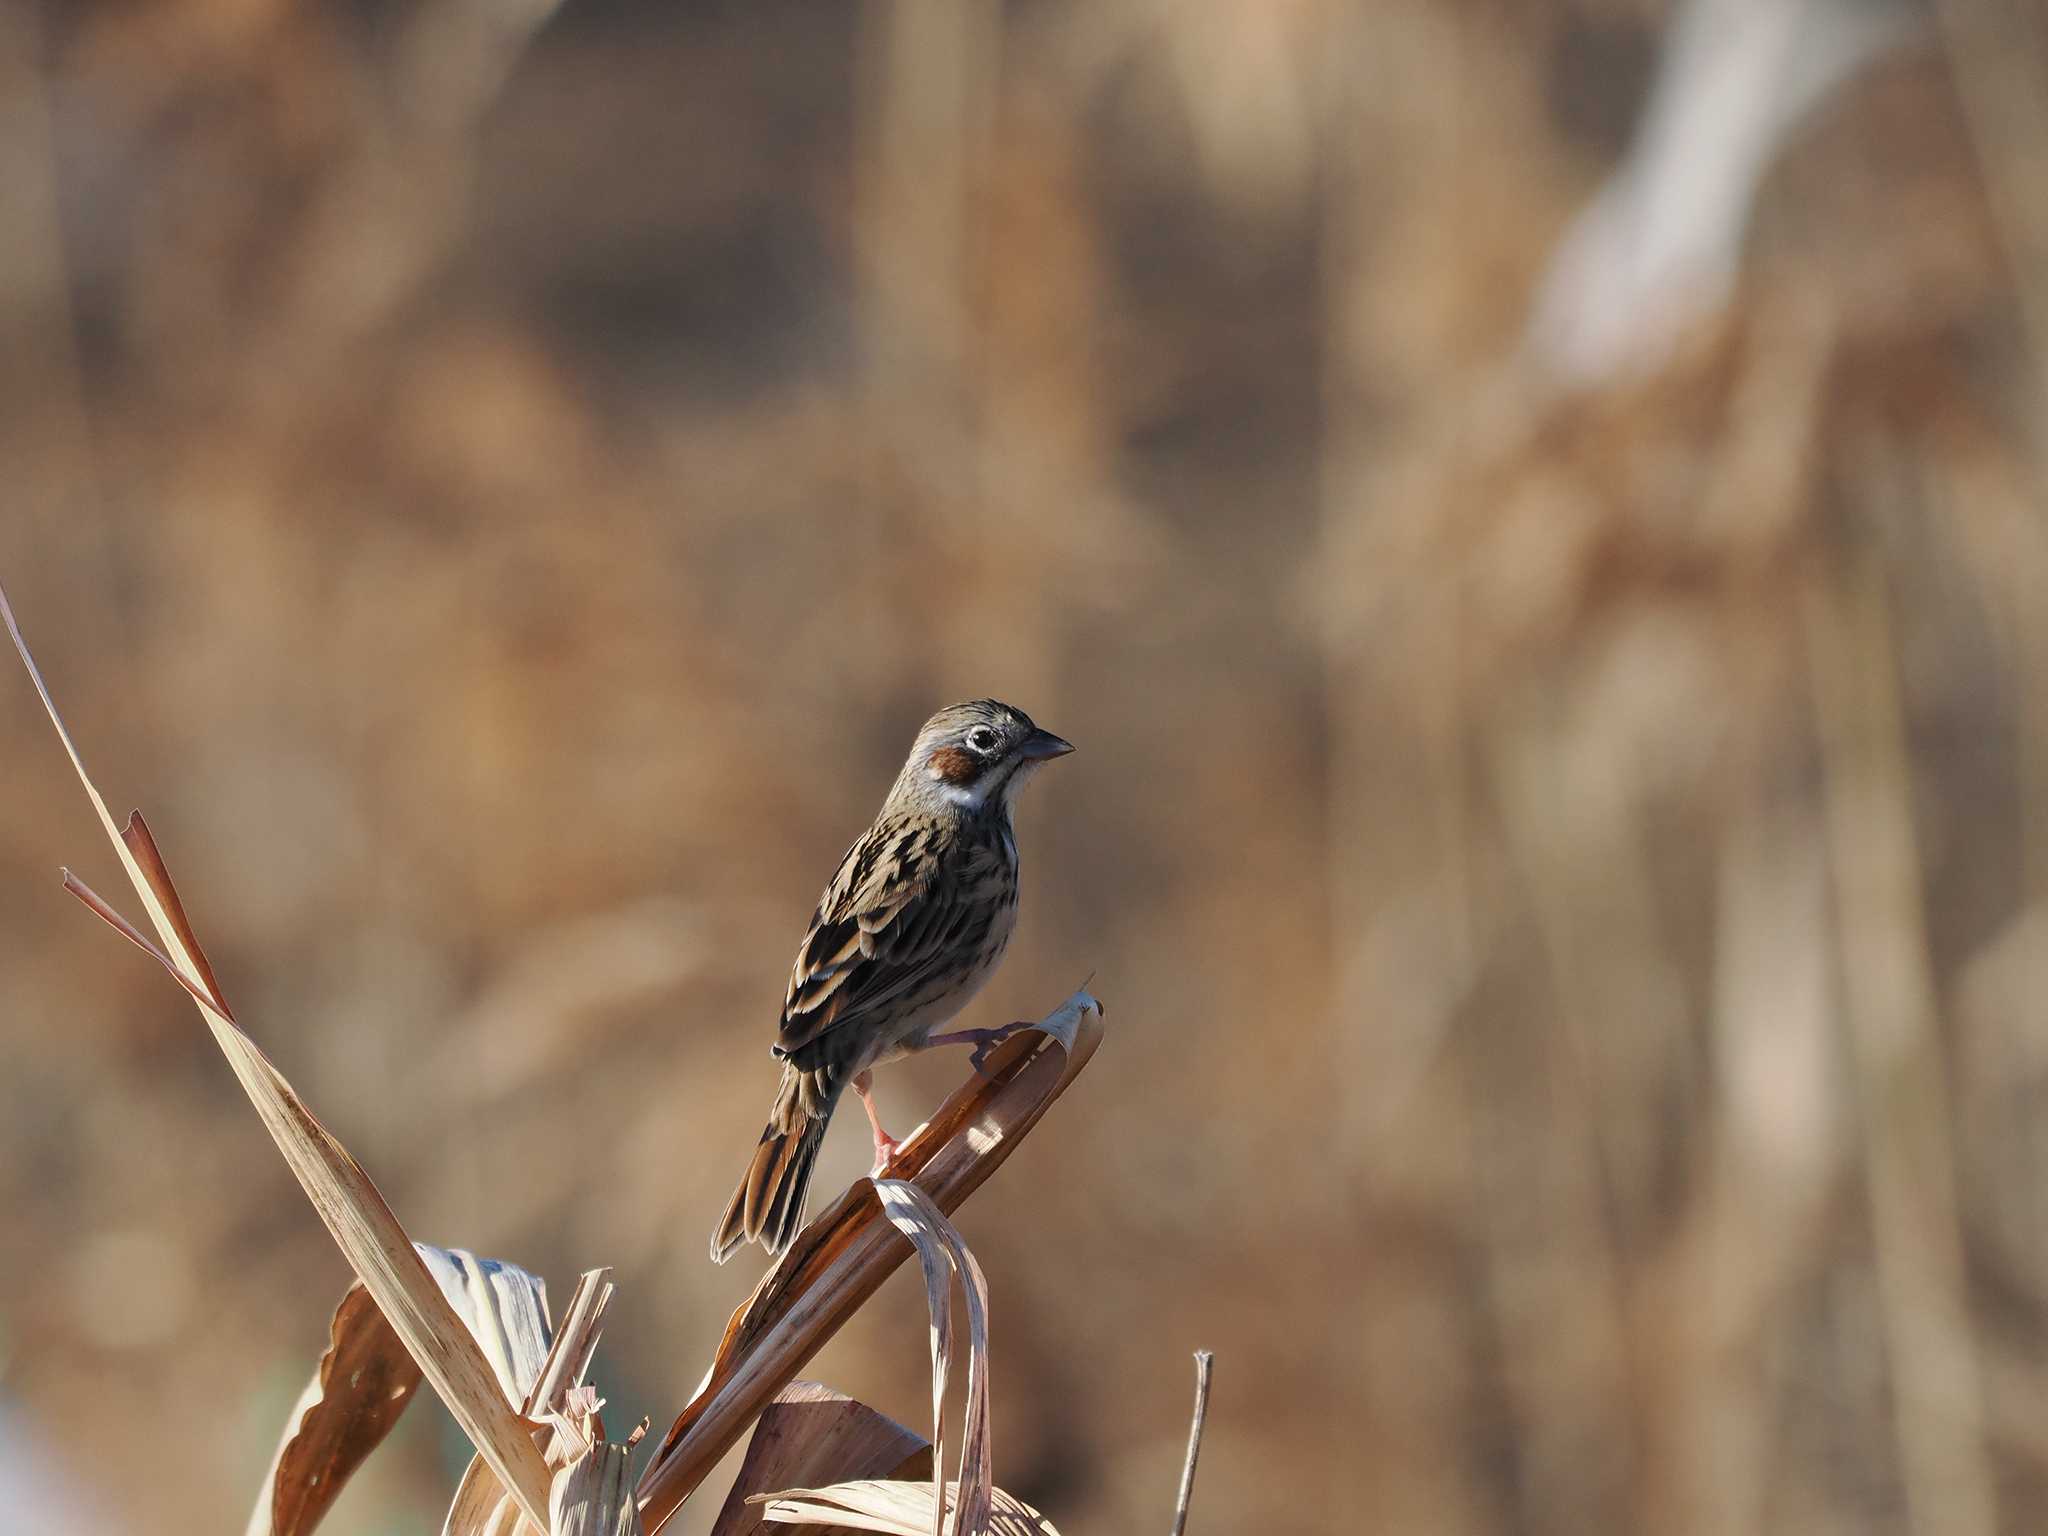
[874,1180,995,1536]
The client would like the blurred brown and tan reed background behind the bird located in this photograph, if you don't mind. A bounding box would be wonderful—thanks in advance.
[0,0,2048,1536]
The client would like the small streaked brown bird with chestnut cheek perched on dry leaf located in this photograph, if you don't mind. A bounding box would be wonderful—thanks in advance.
[711,698,1073,1264]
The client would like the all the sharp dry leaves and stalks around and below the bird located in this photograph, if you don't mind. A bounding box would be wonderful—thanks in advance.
[12,569,1138,1536]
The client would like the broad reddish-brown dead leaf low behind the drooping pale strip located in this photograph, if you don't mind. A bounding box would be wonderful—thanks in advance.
[711,1380,932,1536]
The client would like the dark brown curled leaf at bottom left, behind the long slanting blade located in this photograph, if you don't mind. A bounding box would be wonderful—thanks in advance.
[248,1282,420,1536]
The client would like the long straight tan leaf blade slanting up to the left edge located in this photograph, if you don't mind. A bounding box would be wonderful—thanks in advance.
[0,588,549,1524]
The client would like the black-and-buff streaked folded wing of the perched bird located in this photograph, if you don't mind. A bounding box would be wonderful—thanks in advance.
[776,825,956,1053]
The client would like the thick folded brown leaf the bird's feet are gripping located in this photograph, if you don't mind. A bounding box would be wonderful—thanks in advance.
[639,991,1102,1532]
